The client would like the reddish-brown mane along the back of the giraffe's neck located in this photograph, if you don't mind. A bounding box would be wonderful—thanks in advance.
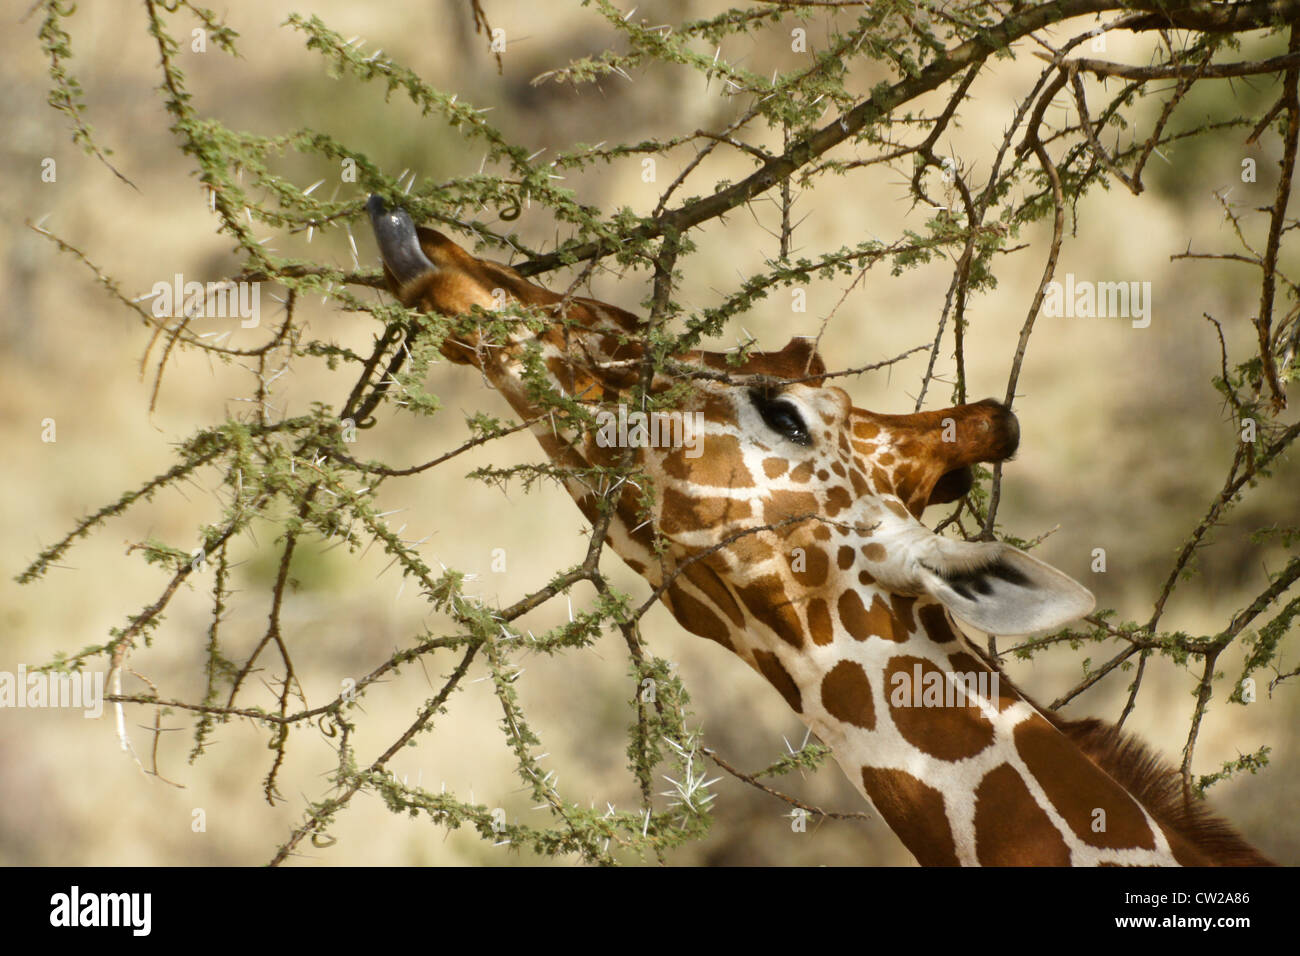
[1039,708,1275,866]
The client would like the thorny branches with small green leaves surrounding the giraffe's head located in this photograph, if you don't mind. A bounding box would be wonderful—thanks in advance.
[20,0,1300,864]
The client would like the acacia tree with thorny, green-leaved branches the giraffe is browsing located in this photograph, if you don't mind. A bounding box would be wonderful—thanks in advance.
[18,0,1300,864]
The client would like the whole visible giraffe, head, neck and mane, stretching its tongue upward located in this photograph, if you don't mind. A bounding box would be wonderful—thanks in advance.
[367,195,1269,866]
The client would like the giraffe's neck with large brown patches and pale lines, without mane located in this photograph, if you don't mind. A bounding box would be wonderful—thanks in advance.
[738,592,1199,866]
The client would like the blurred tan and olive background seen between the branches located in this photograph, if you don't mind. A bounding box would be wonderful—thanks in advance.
[0,0,1300,865]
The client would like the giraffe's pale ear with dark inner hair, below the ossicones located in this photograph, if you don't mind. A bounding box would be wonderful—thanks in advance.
[917,535,1096,635]
